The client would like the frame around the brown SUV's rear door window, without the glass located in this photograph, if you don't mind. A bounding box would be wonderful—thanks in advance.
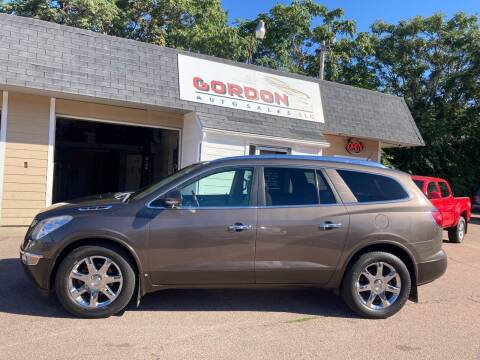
[257,163,344,209]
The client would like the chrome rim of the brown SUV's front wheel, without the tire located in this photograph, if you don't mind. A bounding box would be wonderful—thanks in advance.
[67,256,123,309]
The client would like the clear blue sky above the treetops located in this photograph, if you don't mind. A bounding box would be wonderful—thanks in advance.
[221,0,480,31]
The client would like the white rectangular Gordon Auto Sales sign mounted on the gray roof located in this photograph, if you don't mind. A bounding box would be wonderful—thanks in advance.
[178,54,324,123]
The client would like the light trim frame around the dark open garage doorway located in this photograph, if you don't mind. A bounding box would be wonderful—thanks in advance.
[45,114,183,207]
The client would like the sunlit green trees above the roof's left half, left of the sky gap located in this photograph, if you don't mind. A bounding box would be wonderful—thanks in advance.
[1,0,246,59]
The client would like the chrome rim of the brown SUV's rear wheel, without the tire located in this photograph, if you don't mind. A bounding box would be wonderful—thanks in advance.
[356,262,402,310]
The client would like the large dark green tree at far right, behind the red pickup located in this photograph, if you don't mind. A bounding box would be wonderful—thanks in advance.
[362,13,480,195]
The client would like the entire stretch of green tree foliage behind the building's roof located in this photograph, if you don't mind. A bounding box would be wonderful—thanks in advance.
[0,0,480,194]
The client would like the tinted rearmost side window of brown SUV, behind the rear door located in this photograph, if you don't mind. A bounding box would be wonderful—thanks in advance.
[337,170,408,203]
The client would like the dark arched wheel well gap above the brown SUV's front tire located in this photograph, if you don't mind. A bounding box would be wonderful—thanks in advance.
[50,238,141,289]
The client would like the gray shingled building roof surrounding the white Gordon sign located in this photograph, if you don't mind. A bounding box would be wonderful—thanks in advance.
[0,14,423,146]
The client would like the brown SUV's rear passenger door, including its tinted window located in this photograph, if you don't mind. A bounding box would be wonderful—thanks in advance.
[255,167,349,284]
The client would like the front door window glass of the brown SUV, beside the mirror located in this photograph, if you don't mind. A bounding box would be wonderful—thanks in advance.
[179,168,253,207]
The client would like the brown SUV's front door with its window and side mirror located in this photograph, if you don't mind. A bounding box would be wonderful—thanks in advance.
[149,167,257,285]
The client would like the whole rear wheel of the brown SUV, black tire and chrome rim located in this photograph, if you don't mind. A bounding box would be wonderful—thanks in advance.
[341,252,412,319]
